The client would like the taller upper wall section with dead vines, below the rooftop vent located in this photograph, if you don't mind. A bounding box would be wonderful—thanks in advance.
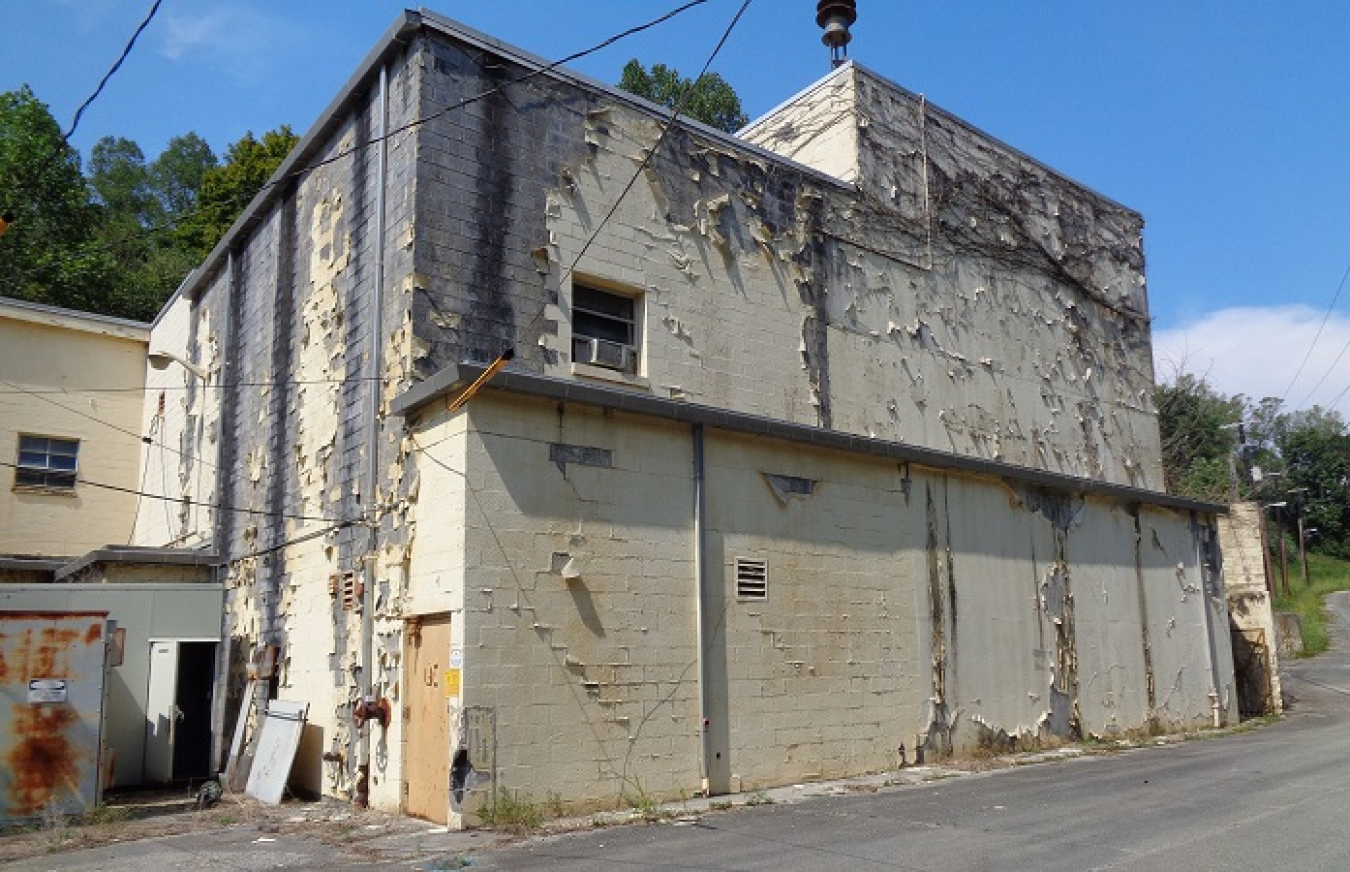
[743,65,1162,489]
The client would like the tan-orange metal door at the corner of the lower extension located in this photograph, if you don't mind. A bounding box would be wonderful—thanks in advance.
[404,616,450,823]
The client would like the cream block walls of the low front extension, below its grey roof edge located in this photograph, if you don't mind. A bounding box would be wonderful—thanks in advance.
[408,391,1237,813]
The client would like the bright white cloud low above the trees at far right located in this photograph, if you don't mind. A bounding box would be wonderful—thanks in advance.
[1153,305,1350,412]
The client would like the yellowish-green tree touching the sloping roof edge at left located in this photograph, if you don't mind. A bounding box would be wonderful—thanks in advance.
[178,124,300,259]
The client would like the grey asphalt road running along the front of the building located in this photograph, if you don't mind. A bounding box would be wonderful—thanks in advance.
[473,594,1350,872]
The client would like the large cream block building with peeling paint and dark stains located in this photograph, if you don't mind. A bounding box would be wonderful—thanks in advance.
[138,11,1237,823]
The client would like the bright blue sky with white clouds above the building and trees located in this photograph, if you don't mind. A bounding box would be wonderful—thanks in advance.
[0,0,1350,412]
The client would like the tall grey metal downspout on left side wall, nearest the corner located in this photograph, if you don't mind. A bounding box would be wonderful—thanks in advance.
[352,63,389,806]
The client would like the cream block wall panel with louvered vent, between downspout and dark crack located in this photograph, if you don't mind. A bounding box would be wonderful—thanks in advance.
[706,432,929,790]
